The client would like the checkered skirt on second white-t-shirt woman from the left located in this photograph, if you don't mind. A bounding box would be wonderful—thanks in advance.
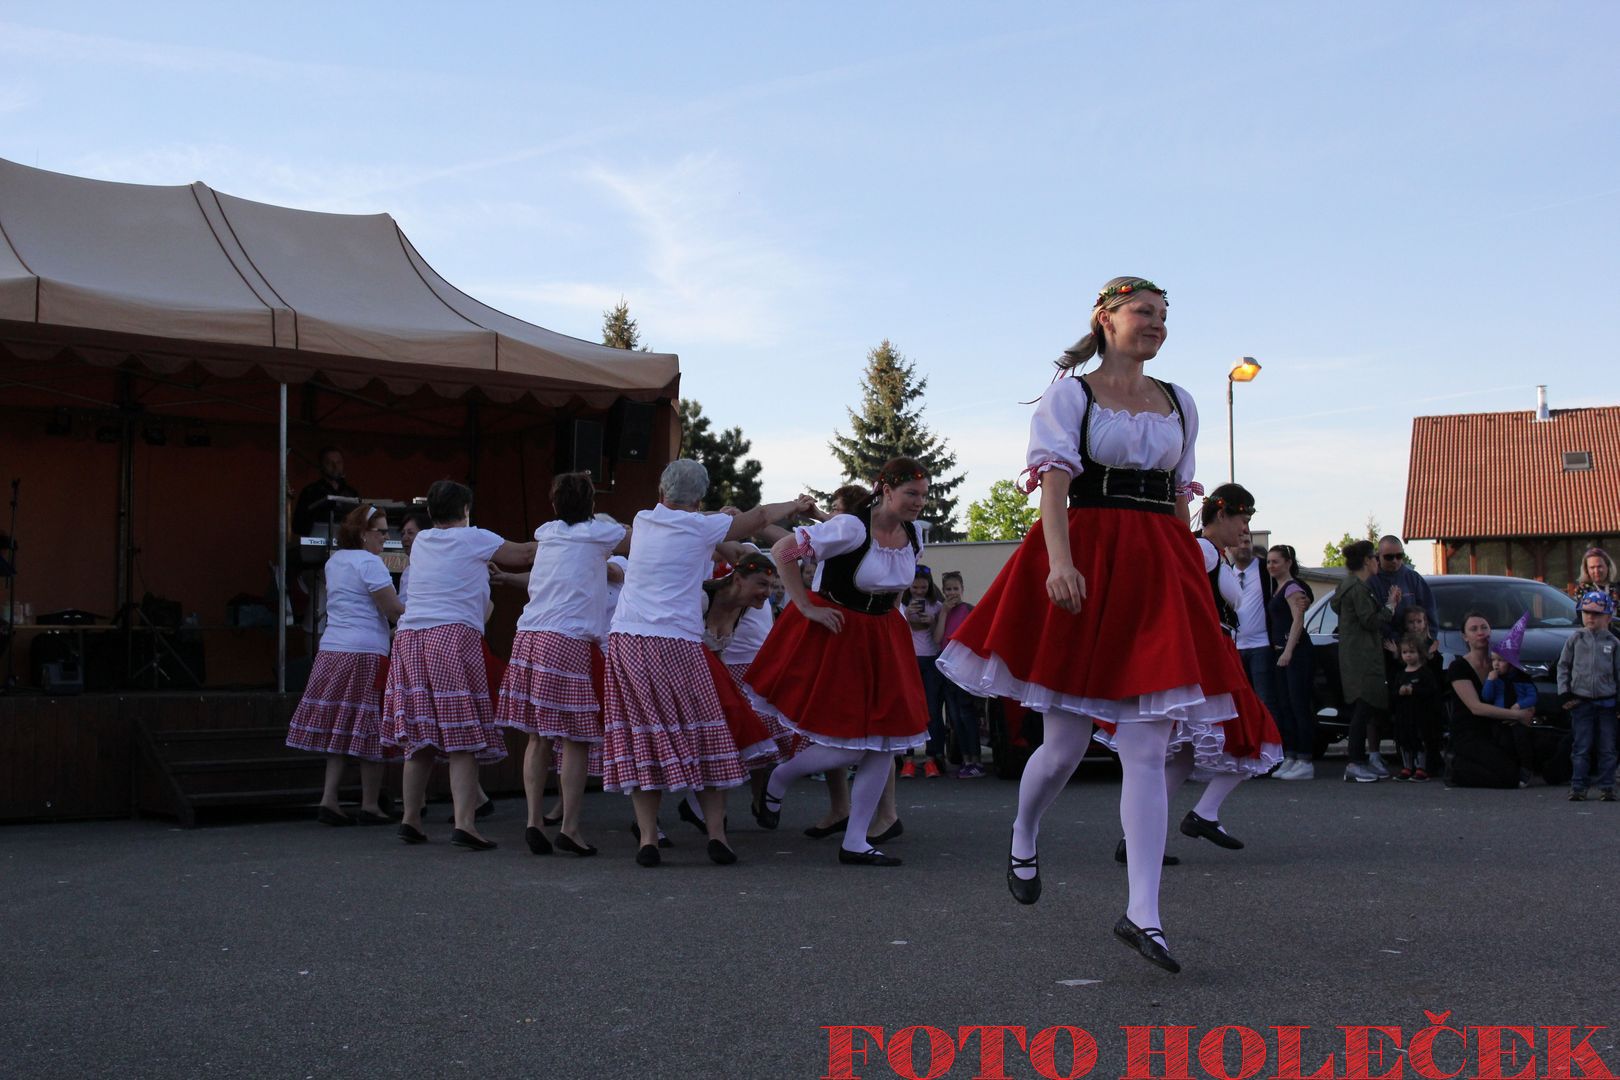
[382,623,505,764]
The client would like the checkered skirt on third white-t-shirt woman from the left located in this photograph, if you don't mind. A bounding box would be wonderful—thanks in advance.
[496,630,604,743]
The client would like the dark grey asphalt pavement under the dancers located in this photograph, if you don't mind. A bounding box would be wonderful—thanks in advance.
[0,759,1620,1080]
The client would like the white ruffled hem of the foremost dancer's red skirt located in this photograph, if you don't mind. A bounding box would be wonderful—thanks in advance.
[935,641,1238,725]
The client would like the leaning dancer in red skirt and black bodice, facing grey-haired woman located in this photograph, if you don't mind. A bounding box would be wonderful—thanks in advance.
[747,458,928,866]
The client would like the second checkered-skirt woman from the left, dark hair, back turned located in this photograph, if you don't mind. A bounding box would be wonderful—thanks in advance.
[382,479,535,852]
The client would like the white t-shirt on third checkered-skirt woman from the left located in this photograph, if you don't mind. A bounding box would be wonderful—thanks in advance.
[517,517,625,641]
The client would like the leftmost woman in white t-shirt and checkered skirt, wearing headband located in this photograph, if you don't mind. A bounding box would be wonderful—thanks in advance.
[287,505,405,826]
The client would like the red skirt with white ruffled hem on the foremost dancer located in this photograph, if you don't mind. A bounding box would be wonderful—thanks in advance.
[938,508,1247,727]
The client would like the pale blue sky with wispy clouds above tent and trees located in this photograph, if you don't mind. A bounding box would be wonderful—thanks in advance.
[0,2,1620,566]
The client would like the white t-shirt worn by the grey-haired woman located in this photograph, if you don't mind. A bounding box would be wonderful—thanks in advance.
[609,504,731,641]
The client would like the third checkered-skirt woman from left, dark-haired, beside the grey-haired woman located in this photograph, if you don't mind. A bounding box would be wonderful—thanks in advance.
[496,473,627,855]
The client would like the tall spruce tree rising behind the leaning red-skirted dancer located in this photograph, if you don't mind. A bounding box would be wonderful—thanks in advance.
[828,338,962,539]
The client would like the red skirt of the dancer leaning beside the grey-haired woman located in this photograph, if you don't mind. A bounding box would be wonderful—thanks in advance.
[745,596,928,753]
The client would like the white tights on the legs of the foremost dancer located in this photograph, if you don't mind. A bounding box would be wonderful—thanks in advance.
[1013,711,1173,926]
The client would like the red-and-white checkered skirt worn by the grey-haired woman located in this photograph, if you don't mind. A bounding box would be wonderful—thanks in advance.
[603,633,748,792]
